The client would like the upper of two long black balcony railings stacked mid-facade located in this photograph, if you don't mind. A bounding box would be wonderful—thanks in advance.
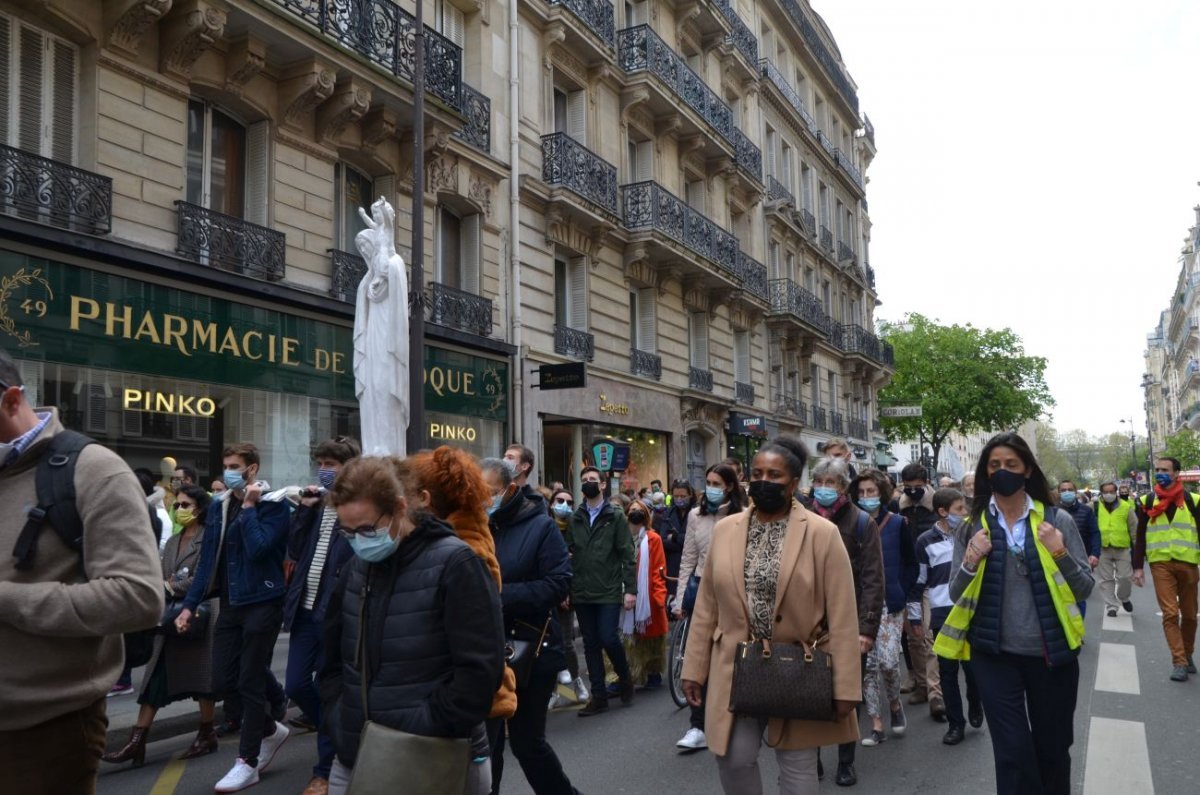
[617,25,733,143]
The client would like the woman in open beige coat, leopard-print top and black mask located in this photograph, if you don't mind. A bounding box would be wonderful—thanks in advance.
[683,436,862,795]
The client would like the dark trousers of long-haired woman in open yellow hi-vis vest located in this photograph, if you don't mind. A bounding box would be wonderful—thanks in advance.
[969,648,1079,795]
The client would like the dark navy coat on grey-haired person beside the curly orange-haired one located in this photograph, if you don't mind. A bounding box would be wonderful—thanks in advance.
[491,491,571,676]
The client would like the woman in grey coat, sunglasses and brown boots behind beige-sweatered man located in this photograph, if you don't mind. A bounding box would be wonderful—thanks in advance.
[102,485,220,767]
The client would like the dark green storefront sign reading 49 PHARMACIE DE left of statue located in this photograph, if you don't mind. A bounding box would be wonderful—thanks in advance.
[0,251,354,401]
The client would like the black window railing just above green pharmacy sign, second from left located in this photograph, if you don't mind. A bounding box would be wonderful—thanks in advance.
[175,202,287,281]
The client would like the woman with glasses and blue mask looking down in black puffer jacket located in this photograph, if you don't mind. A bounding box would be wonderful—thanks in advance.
[320,458,505,795]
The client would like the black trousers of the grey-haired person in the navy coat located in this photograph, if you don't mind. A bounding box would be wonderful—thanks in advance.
[487,671,576,795]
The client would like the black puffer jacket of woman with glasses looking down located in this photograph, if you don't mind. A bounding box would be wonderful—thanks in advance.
[320,519,504,767]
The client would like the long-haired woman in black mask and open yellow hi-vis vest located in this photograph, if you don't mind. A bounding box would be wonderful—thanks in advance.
[934,434,1094,795]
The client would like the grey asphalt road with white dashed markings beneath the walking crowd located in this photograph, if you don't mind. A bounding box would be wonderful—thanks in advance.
[98,587,1200,795]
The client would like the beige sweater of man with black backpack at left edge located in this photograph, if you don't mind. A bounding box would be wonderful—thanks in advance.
[0,408,163,731]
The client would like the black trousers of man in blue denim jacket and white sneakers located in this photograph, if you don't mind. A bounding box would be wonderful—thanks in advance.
[212,598,283,765]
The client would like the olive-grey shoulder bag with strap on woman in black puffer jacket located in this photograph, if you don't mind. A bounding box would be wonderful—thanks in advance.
[346,575,470,795]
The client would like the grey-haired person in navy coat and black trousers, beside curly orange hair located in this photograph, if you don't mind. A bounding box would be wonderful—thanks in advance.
[479,459,572,795]
